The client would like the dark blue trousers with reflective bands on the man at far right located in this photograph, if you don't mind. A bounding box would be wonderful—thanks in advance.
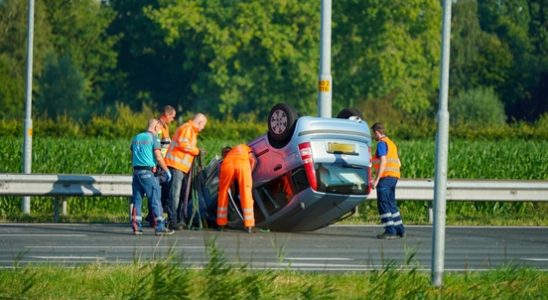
[376,177,405,235]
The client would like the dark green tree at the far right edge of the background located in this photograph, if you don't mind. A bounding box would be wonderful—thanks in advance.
[478,0,548,120]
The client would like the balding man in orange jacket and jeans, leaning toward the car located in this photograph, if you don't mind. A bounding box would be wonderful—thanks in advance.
[164,113,207,230]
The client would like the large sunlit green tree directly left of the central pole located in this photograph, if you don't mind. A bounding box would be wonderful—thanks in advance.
[148,0,320,117]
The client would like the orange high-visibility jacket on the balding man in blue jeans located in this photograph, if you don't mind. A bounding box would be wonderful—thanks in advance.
[164,120,200,173]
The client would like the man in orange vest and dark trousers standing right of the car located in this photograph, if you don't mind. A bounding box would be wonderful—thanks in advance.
[371,123,405,240]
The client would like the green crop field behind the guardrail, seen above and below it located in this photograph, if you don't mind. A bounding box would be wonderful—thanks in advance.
[0,137,548,225]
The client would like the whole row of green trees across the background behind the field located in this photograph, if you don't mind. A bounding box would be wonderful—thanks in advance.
[0,0,548,125]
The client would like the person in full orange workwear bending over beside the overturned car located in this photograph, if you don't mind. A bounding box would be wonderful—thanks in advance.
[217,144,256,233]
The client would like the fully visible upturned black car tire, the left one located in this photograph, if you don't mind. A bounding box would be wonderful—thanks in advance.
[268,103,298,148]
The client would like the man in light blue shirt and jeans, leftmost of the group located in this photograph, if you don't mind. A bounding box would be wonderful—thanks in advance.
[130,119,174,235]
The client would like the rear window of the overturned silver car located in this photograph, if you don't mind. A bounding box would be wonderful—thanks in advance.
[316,163,369,195]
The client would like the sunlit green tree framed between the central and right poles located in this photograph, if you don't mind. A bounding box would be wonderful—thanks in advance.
[333,0,441,114]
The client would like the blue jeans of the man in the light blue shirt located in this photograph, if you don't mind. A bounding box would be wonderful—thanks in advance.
[131,169,164,231]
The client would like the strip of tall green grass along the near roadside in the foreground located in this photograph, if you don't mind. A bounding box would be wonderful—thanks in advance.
[0,241,548,300]
